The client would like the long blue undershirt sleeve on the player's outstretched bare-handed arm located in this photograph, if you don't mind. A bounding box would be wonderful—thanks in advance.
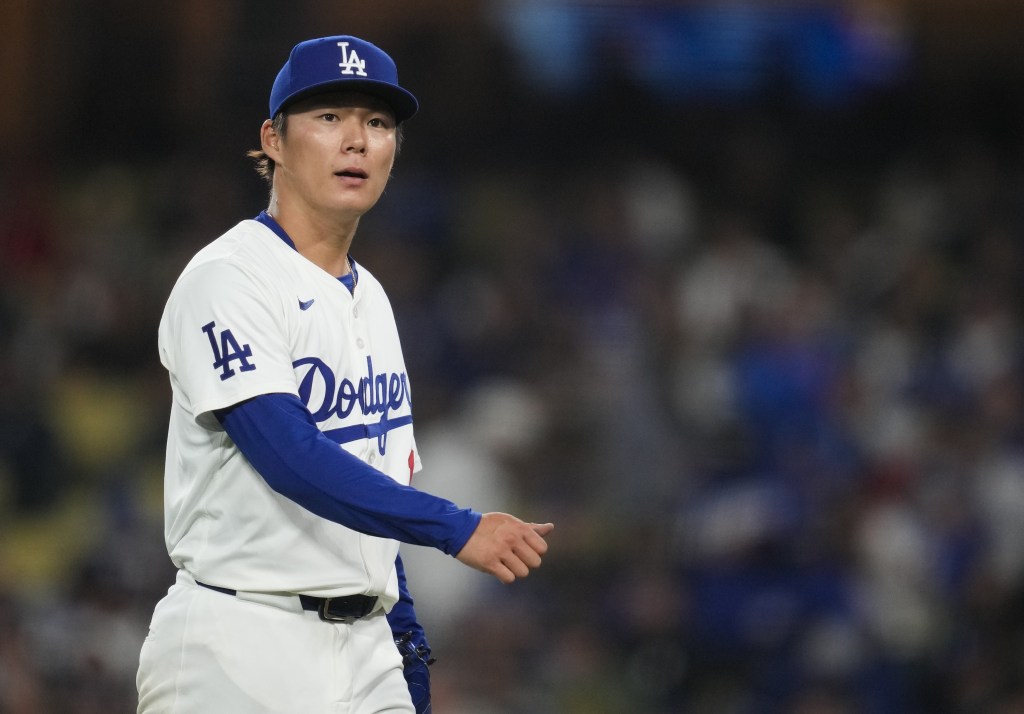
[216,393,480,555]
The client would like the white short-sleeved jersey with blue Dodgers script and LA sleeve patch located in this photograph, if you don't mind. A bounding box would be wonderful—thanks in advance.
[159,220,420,608]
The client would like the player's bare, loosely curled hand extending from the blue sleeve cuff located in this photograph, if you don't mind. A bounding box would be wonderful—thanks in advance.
[456,513,555,584]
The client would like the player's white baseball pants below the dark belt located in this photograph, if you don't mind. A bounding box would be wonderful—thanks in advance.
[136,571,414,714]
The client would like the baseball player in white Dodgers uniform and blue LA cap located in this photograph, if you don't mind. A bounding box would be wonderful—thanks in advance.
[137,36,553,714]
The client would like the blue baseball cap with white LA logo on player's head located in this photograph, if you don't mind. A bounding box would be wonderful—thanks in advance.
[270,35,420,122]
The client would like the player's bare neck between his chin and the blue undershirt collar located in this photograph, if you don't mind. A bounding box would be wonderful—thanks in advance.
[267,197,359,278]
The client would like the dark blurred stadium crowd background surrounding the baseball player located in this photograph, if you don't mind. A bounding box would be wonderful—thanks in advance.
[0,0,1024,714]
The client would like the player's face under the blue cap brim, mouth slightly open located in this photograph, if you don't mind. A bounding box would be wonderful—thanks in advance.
[264,92,396,217]
